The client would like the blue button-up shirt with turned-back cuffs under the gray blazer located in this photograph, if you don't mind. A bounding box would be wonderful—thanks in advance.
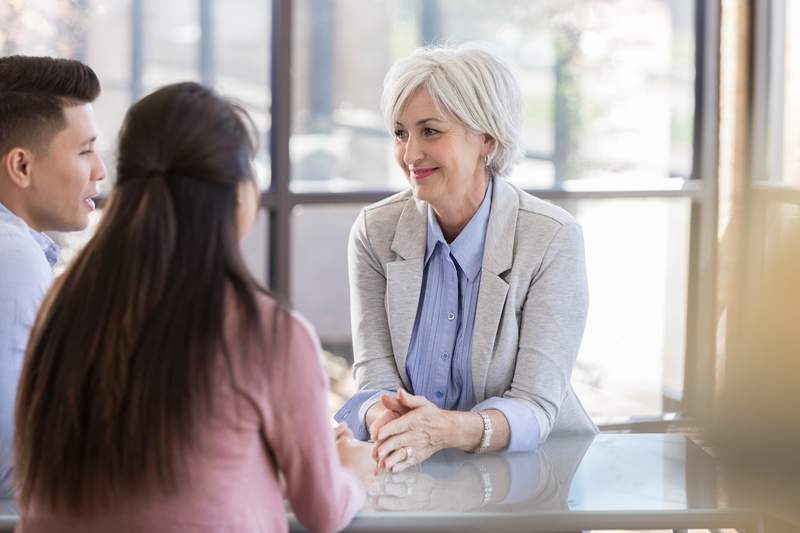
[334,180,539,451]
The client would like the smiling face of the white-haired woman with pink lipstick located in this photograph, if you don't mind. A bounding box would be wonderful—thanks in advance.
[394,89,494,208]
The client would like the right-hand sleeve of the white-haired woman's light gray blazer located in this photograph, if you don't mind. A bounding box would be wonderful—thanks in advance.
[503,222,589,442]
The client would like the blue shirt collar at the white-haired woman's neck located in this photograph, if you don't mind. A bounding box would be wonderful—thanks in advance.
[425,178,493,281]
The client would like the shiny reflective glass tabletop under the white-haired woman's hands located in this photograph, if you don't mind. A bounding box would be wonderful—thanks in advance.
[361,434,718,515]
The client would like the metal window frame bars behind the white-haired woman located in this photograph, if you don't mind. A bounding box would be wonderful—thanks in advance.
[120,0,721,430]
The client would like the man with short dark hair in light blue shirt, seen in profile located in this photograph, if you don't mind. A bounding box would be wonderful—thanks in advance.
[0,56,106,494]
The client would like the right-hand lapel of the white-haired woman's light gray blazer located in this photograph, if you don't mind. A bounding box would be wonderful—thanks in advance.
[472,178,519,402]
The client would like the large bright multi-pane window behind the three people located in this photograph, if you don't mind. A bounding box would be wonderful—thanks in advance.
[0,0,716,424]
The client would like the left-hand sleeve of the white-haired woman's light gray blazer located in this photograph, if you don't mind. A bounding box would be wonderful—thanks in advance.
[347,210,400,391]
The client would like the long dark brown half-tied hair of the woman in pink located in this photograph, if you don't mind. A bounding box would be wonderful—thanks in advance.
[15,83,262,512]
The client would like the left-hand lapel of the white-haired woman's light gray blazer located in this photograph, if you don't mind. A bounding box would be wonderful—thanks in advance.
[386,198,428,391]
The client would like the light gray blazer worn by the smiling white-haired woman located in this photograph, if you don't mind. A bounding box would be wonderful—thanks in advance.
[348,179,597,440]
